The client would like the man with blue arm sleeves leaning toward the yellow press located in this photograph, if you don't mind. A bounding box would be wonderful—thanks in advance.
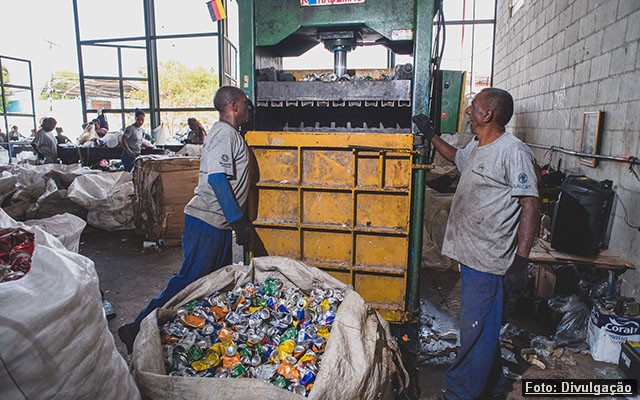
[118,86,252,353]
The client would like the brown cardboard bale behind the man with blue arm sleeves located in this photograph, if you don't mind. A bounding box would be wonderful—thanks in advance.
[133,156,200,246]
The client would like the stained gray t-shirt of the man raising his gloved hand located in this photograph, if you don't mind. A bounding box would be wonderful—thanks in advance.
[442,133,538,275]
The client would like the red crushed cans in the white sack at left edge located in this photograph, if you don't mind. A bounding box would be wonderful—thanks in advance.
[0,228,34,283]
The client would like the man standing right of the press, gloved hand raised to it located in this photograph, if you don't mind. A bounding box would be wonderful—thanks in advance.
[413,88,539,399]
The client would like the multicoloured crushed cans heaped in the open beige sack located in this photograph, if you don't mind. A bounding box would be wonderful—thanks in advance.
[160,278,344,396]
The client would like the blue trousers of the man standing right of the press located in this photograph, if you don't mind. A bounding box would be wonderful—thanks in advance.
[445,264,506,400]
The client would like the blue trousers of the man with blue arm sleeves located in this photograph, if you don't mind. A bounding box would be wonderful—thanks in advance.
[136,215,232,326]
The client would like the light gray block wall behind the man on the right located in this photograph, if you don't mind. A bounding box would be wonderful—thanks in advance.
[494,0,640,299]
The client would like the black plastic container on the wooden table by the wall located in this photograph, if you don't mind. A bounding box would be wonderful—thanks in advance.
[551,175,614,255]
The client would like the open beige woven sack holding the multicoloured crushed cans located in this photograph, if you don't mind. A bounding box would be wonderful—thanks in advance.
[132,257,409,400]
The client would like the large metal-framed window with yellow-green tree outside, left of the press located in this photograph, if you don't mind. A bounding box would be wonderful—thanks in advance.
[74,0,238,134]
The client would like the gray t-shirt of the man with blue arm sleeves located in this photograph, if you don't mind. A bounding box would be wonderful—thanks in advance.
[184,121,249,229]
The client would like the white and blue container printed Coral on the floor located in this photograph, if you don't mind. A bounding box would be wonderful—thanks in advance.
[587,300,640,364]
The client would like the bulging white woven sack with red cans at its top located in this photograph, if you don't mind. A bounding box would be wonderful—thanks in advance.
[0,211,140,400]
